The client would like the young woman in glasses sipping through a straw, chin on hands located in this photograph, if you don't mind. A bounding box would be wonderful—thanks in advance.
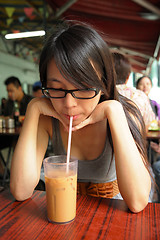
[10,20,151,212]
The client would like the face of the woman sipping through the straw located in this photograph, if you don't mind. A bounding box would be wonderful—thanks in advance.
[47,60,101,126]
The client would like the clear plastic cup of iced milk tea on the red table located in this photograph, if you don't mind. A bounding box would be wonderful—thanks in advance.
[43,155,78,224]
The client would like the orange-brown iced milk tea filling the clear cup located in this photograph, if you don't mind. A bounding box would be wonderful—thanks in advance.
[45,171,77,224]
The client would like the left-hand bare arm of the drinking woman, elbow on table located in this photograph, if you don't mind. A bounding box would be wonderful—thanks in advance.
[10,99,57,201]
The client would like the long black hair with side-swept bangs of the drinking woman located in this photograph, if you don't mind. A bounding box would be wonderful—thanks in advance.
[39,21,147,169]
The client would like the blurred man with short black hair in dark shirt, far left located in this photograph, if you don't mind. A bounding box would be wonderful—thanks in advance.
[4,76,32,116]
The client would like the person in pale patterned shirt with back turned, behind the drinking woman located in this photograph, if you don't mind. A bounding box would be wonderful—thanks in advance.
[112,52,155,130]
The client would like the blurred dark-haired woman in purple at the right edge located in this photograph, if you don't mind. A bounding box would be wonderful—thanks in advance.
[136,76,160,120]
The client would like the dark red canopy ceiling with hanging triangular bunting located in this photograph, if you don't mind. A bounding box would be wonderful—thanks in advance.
[0,0,160,73]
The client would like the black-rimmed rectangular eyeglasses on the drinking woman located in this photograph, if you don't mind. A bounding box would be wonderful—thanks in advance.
[42,87,99,99]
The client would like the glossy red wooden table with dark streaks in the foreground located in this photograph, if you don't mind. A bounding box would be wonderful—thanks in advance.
[0,190,160,240]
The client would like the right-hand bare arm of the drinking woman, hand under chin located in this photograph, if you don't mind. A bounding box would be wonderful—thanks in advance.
[73,100,151,212]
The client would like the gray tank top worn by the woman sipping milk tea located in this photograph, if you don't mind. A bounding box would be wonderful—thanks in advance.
[52,118,117,183]
